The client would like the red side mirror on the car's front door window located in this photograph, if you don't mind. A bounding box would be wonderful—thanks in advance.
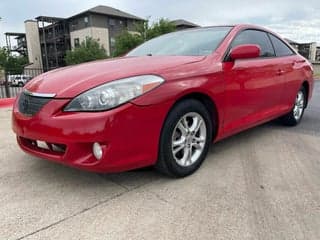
[230,44,261,60]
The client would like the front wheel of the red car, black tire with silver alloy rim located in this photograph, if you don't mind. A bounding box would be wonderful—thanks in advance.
[155,99,213,178]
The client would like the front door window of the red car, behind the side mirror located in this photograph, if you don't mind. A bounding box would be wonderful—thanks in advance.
[231,30,275,57]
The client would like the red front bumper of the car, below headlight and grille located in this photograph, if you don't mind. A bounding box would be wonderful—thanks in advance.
[12,99,171,172]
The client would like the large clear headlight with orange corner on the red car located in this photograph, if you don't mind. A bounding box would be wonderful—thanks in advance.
[64,75,164,112]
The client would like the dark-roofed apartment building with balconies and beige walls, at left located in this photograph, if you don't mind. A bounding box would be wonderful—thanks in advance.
[25,5,145,70]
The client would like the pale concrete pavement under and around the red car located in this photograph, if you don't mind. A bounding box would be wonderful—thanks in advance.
[0,82,320,240]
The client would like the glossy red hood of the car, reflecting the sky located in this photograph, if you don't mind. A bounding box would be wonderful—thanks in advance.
[25,56,205,98]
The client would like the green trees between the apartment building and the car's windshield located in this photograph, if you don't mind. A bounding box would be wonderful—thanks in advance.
[112,18,176,57]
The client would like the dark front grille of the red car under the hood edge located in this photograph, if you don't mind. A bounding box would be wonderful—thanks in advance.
[18,92,52,116]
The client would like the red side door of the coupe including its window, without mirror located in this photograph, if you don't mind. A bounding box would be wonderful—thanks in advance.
[223,29,284,135]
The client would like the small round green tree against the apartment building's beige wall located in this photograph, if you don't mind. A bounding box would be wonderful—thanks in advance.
[65,37,108,65]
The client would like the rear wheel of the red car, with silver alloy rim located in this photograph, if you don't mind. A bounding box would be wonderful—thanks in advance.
[280,87,307,126]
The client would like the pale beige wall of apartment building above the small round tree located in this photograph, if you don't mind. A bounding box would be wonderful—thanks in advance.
[70,27,110,55]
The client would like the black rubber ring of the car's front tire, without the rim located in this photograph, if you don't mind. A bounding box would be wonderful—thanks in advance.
[159,99,213,177]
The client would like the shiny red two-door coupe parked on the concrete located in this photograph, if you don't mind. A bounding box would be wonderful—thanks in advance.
[12,25,313,177]
